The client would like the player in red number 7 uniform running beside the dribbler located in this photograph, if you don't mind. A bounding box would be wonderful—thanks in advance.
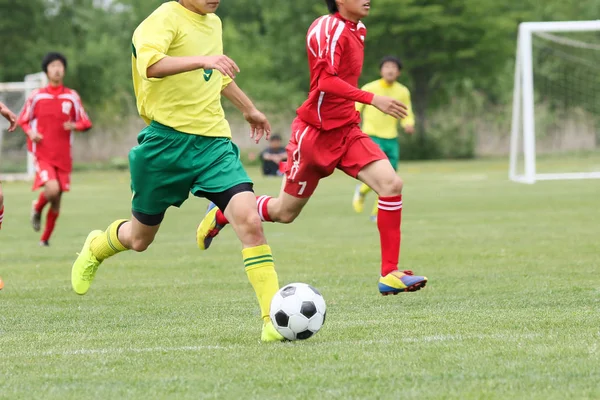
[197,0,427,295]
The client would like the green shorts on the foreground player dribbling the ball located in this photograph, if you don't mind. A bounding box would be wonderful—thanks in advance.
[129,122,252,215]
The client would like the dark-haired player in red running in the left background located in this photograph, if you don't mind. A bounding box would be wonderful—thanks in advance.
[18,53,92,246]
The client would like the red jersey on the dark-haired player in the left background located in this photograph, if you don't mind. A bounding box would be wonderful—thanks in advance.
[18,86,92,172]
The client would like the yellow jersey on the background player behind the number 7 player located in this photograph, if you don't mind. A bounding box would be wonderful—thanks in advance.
[356,79,415,139]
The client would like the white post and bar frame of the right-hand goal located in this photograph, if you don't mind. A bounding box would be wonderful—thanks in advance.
[509,20,600,184]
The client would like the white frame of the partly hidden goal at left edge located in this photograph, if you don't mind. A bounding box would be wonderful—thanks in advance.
[0,72,48,181]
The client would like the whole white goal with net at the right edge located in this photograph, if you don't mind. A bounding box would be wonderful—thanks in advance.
[509,20,600,183]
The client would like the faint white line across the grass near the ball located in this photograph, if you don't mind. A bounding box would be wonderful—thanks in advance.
[5,333,542,357]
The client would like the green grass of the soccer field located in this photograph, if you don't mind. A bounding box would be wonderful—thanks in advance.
[0,158,600,399]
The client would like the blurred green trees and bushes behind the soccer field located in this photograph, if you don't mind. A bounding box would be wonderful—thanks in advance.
[0,0,600,159]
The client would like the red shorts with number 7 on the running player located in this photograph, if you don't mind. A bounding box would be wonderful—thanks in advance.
[284,118,387,198]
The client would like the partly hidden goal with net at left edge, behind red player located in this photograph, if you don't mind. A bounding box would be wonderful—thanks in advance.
[0,72,48,180]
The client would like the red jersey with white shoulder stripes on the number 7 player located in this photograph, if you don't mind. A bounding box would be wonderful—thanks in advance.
[297,13,374,131]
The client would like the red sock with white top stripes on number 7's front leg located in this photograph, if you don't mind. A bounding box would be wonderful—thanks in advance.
[377,195,402,276]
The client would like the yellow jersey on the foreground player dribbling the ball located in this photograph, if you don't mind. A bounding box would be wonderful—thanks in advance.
[131,1,231,137]
